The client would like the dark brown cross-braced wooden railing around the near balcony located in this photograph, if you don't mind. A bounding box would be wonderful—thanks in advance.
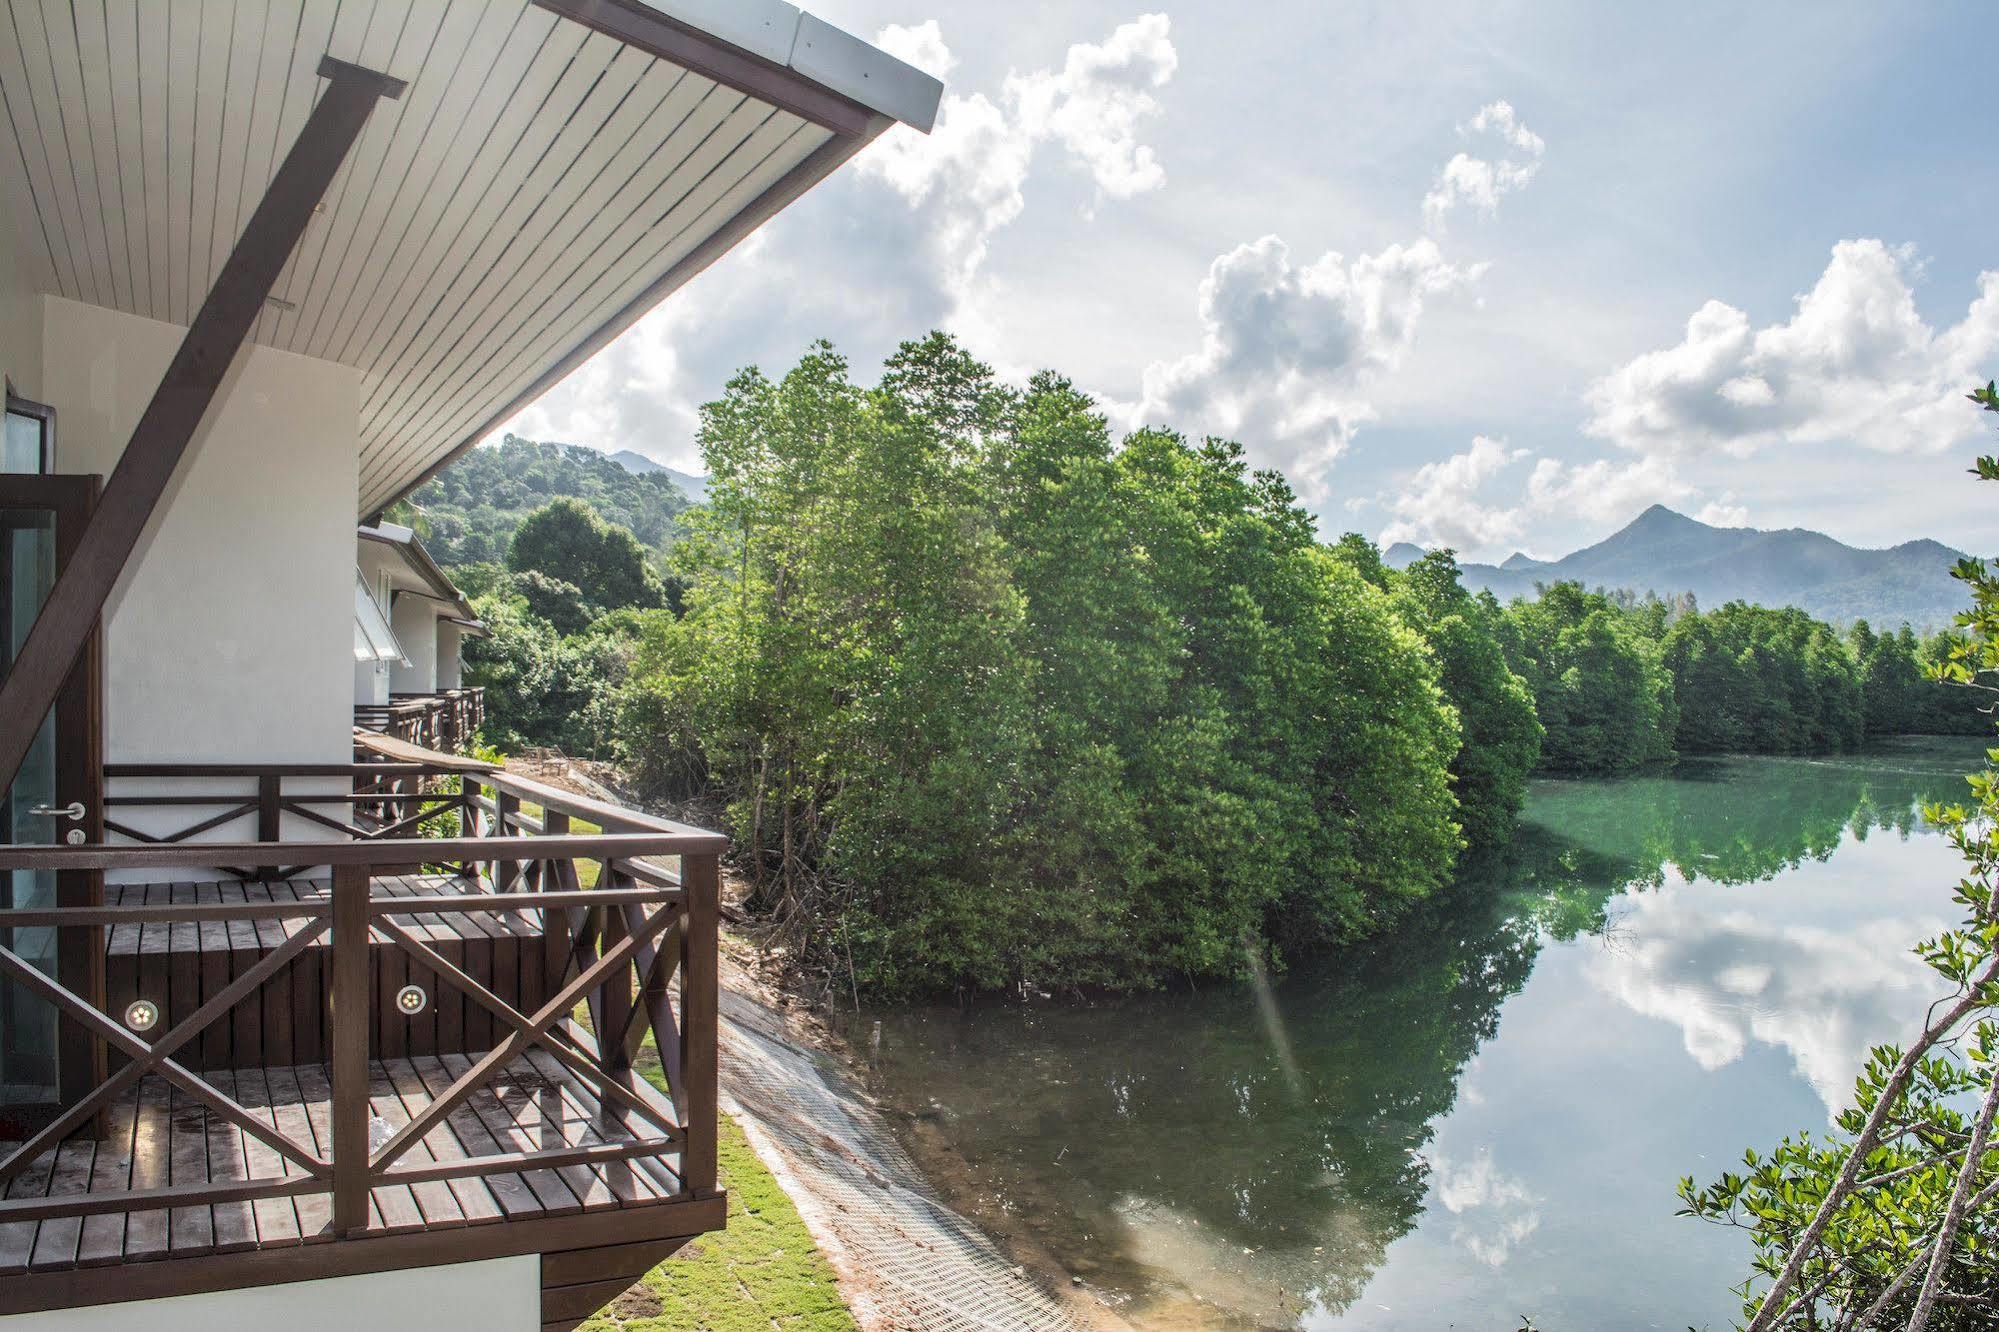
[0,764,726,1236]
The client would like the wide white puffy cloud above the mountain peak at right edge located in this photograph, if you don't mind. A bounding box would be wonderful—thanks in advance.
[1585,240,1999,456]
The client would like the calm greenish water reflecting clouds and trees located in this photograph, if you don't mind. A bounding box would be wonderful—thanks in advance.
[854,742,1979,1332]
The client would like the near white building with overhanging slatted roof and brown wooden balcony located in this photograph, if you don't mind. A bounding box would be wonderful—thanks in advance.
[0,0,940,1332]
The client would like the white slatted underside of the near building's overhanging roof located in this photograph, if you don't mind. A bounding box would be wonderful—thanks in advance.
[0,0,938,514]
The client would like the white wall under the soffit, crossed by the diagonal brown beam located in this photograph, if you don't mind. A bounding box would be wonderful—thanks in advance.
[42,296,360,762]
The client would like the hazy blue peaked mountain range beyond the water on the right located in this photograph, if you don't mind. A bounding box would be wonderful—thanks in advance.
[1381,504,1967,630]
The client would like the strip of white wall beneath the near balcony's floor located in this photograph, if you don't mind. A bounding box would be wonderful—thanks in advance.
[0,1254,542,1332]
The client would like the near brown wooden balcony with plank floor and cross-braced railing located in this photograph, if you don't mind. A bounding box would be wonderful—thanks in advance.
[0,762,724,1328]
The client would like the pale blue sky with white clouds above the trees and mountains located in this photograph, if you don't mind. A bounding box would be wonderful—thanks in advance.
[504,0,1999,560]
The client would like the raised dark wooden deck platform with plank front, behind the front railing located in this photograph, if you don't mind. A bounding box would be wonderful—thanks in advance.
[104,874,550,1068]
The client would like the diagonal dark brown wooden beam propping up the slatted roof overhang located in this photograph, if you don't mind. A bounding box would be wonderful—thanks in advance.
[0,56,404,786]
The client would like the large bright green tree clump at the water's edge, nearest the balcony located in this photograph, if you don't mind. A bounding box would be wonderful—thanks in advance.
[624,336,1459,990]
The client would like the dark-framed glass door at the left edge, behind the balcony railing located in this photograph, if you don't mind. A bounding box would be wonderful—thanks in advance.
[0,398,104,1138]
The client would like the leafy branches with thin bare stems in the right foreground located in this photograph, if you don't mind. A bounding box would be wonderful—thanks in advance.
[1679,386,1999,1332]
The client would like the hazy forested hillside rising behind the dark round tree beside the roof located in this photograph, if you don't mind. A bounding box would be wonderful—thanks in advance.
[397,434,688,566]
